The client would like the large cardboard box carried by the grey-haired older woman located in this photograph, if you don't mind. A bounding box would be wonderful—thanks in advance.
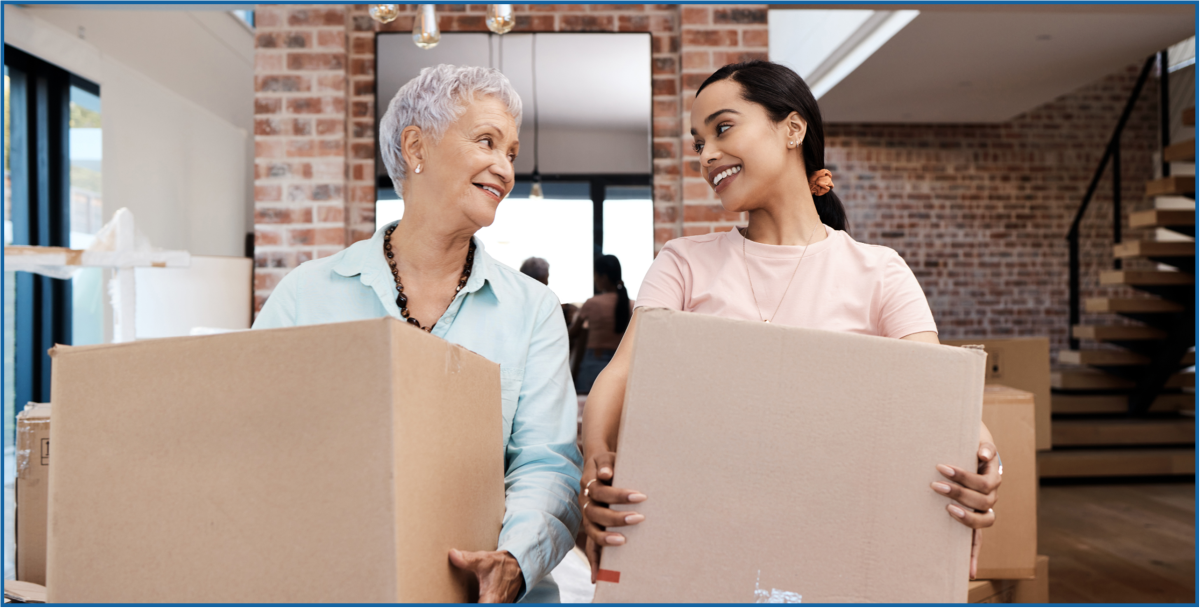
[47,319,504,602]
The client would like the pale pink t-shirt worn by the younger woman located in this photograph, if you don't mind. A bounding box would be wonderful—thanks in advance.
[637,225,937,338]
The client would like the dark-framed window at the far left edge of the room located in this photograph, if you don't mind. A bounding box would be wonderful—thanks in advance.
[4,44,102,579]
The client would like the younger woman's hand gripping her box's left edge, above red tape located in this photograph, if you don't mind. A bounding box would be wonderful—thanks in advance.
[580,452,646,584]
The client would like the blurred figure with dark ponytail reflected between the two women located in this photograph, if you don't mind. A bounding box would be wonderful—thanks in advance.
[568,255,634,395]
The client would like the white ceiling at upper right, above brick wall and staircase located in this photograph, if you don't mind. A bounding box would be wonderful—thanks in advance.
[772,5,1195,122]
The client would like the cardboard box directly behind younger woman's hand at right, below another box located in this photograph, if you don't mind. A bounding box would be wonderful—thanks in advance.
[976,385,1038,579]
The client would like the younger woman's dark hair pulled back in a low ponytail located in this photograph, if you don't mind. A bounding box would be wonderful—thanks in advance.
[696,60,850,231]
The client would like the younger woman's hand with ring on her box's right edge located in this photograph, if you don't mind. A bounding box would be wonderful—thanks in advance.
[930,438,1000,579]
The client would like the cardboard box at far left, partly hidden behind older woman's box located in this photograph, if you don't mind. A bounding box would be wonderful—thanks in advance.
[16,403,50,585]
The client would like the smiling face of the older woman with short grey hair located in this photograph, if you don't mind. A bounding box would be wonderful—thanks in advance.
[409,97,521,229]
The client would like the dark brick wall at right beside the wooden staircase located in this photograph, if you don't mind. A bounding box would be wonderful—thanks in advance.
[826,62,1158,351]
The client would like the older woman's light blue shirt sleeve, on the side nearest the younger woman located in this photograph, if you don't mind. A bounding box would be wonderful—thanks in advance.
[499,294,583,600]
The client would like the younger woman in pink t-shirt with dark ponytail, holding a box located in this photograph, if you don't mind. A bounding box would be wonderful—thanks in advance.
[580,61,1000,582]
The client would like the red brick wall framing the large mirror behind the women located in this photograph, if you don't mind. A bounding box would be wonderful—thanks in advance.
[254,5,767,308]
